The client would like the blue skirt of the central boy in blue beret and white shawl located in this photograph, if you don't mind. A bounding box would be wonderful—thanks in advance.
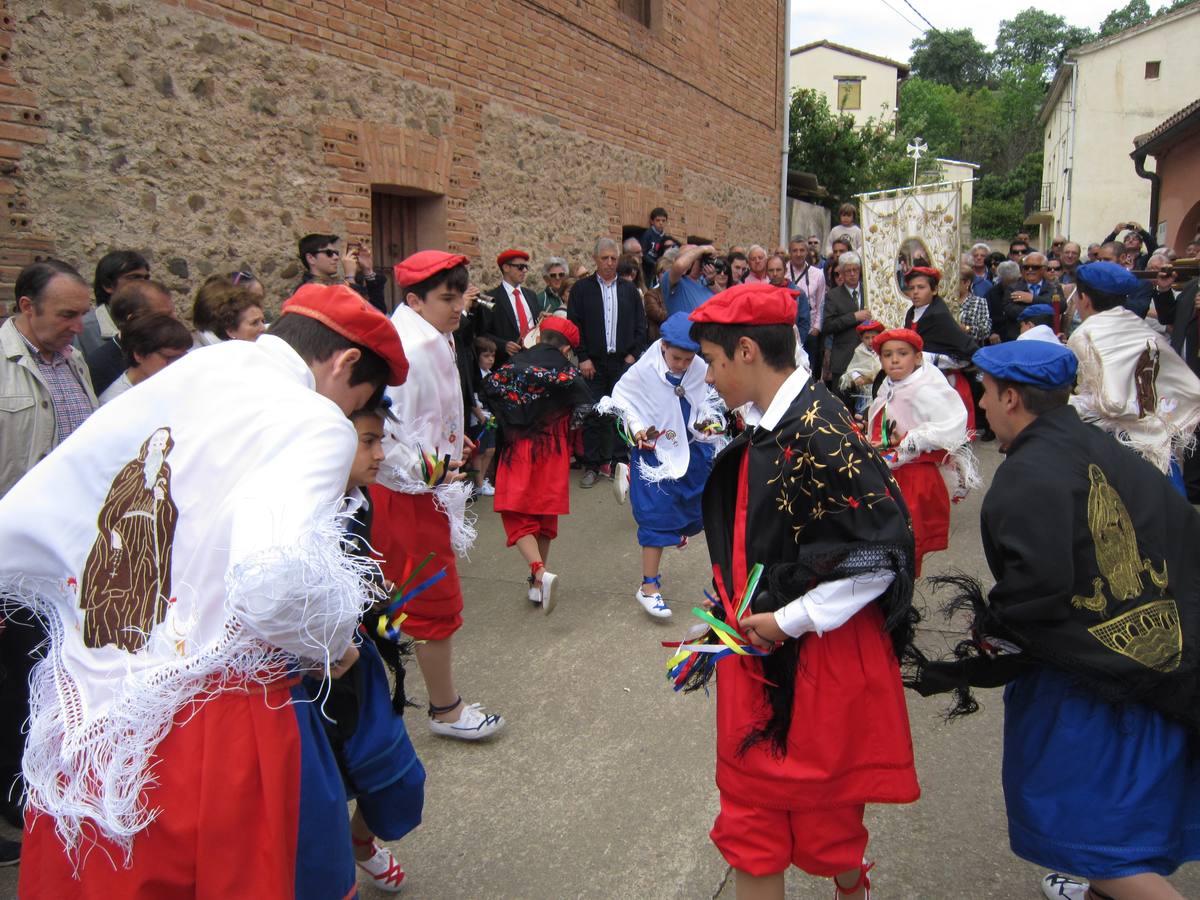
[629,440,713,547]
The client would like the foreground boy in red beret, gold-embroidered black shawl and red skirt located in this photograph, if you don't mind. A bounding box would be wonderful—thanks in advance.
[691,284,920,900]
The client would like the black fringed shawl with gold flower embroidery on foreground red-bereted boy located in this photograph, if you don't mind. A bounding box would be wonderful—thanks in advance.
[685,379,919,755]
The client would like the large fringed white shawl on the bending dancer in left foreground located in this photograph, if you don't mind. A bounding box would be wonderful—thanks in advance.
[0,336,371,851]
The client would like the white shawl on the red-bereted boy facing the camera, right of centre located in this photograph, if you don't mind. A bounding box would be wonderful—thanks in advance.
[868,365,980,502]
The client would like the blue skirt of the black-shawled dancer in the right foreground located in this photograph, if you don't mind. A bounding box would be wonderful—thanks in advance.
[1003,668,1200,880]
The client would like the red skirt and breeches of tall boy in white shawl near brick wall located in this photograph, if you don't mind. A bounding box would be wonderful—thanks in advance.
[371,485,462,641]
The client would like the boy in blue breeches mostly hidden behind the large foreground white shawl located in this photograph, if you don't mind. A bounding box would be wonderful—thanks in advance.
[305,407,425,893]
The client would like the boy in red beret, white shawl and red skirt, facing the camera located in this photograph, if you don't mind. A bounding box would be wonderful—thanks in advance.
[866,328,979,577]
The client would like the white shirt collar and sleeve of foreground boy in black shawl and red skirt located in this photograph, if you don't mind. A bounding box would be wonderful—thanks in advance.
[743,368,895,637]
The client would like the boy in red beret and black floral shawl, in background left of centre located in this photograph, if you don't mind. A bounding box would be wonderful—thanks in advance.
[484,316,592,614]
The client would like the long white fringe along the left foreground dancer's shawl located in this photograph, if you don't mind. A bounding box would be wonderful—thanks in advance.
[0,515,374,864]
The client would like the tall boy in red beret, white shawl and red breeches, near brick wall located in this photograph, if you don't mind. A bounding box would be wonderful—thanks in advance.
[371,250,504,740]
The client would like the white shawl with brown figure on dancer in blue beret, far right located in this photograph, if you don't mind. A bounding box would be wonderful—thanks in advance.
[1067,307,1200,472]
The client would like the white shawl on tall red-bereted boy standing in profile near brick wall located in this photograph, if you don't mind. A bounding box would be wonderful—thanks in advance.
[377,305,475,556]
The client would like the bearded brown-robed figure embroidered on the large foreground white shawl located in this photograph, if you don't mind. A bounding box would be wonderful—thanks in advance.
[79,428,179,653]
